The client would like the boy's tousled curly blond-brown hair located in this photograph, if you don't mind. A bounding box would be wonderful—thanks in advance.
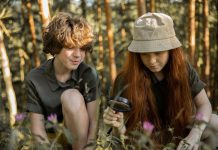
[43,12,94,55]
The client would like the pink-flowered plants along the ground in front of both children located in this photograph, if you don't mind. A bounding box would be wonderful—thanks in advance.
[0,110,218,150]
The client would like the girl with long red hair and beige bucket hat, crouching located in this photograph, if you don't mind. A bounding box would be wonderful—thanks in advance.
[103,13,218,150]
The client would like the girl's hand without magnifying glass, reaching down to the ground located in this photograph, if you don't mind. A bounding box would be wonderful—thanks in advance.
[176,128,202,150]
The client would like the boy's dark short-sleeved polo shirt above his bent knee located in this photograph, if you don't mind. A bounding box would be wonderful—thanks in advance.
[25,58,100,121]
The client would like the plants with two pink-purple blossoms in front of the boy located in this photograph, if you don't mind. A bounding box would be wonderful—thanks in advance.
[0,113,72,150]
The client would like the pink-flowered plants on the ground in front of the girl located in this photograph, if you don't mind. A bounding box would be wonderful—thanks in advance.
[91,113,218,150]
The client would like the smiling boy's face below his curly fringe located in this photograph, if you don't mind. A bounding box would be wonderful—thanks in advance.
[56,48,86,71]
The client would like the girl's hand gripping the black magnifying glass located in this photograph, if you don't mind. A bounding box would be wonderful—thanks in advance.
[103,107,125,133]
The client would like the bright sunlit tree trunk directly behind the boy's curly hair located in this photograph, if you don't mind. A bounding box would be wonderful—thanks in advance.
[38,0,52,59]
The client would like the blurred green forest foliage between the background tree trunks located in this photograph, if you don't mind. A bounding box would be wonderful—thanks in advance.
[0,0,218,103]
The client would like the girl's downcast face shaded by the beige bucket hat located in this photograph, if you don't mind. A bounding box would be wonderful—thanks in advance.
[140,51,169,73]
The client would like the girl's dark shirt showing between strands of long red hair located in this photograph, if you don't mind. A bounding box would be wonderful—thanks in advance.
[113,64,205,118]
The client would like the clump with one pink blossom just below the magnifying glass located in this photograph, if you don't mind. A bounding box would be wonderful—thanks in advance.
[87,122,154,150]
